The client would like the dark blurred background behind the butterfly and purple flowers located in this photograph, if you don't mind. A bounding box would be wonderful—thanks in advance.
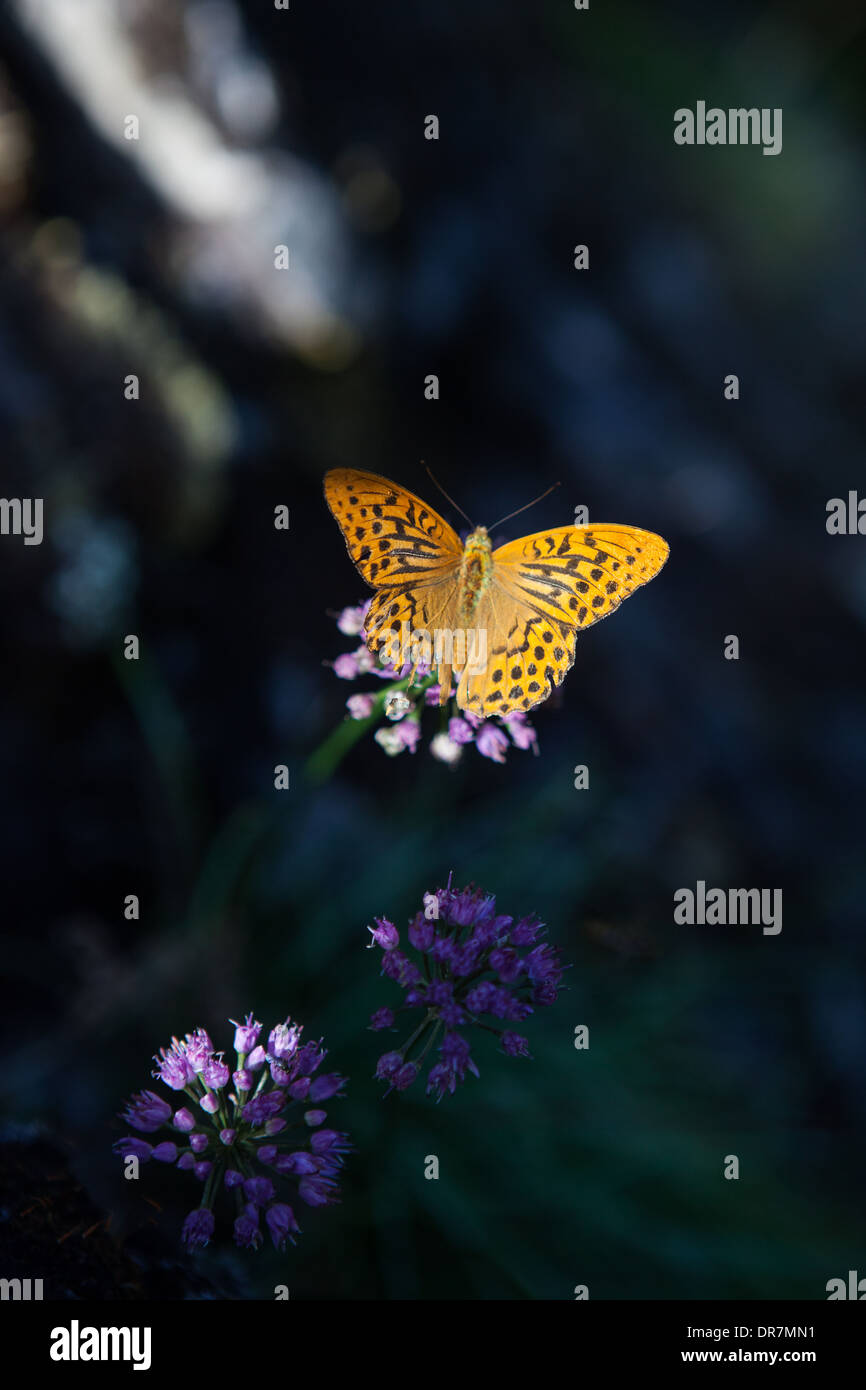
[0,0,866,1300]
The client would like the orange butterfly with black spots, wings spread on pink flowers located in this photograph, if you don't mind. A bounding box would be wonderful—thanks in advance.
[325,468,669,719]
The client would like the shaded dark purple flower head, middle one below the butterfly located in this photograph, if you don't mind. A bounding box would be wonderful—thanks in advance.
[367,877,563,1099]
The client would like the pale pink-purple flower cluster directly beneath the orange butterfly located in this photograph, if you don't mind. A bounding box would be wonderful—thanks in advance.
[331,600,538,763]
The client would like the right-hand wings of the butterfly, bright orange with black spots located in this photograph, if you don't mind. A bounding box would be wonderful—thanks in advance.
[457,524,669,717]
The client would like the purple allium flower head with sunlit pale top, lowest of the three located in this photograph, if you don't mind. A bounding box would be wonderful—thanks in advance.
[114,1013,350,1250]
